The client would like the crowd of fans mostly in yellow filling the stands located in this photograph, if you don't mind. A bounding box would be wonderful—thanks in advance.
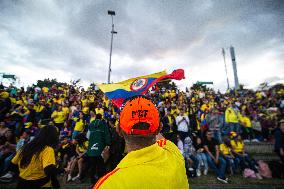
[0,81,284,186]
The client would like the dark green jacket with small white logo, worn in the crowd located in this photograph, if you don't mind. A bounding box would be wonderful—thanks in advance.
[87,119,111,157]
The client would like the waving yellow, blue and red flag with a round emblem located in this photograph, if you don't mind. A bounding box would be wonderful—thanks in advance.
[97,69,184,107]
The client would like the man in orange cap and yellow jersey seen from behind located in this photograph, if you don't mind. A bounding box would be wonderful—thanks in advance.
[93,96,189,189]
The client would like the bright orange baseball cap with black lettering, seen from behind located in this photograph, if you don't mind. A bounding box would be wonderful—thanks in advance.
[119,96,160,135]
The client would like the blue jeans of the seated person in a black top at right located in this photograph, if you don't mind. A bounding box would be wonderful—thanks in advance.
[206,153,227,179]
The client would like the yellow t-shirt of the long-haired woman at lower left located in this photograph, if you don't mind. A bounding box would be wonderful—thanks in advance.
[12,146,56,187]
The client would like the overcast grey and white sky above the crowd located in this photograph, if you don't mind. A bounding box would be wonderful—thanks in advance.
[0,0,284,90]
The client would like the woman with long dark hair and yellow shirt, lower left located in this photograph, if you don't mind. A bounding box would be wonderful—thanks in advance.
[12,126,60,189]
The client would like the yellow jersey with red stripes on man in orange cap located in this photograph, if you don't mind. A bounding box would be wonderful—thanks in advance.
[93,140,189,189]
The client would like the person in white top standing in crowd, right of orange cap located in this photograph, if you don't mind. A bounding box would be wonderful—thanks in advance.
[176,109,189,141]
